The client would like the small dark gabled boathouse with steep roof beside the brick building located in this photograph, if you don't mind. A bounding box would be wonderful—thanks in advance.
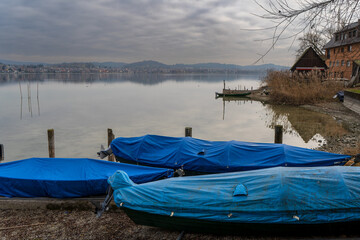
[290,47,328,73]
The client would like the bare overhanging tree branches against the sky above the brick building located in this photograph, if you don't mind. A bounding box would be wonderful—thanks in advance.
[254,0,360,62]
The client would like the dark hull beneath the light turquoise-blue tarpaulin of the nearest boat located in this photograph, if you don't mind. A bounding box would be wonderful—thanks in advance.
[122,208,360,236]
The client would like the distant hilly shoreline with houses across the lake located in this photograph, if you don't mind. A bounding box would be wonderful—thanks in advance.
[0,60,288,74]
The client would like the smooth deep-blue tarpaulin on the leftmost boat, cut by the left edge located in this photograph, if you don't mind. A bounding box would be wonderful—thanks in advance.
[0,158,173,198]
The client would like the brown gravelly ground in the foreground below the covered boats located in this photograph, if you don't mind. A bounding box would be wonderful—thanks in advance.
[0,206,359,240]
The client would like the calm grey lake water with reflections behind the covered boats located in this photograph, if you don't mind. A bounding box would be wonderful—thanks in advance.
[0,74,346,162]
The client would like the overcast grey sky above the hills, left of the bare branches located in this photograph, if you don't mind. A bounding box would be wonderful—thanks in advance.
[0,0,297,66]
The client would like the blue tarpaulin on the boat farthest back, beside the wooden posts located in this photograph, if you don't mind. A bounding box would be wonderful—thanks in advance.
[111,135,350,173]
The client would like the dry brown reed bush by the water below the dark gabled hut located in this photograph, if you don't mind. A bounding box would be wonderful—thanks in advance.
[263,71,343,105]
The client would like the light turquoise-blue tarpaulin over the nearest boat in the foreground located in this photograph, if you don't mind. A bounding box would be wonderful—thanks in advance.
[109,166,360,224]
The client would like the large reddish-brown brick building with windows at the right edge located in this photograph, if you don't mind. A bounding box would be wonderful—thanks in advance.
[324,19,360,80]
